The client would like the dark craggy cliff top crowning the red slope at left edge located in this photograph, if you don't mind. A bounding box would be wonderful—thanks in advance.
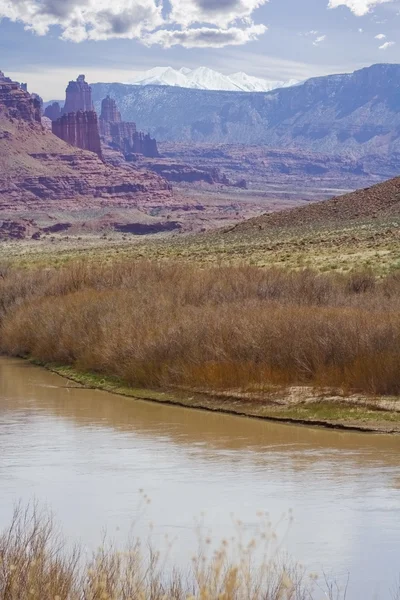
[0,71,41,123]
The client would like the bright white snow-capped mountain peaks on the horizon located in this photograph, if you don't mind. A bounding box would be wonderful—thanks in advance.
[128,67,298,92]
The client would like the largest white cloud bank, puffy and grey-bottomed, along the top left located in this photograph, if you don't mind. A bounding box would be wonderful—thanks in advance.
[0,0,268,47]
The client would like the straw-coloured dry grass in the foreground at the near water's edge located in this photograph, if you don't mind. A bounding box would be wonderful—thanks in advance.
[0,506,318,600]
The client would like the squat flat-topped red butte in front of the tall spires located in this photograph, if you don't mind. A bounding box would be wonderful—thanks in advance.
[52,111,102,158]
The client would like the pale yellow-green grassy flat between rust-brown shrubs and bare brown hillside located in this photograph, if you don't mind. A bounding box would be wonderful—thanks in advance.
[0,211,400,276]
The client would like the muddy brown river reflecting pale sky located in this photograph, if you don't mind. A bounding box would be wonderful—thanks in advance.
[0,359,400,600]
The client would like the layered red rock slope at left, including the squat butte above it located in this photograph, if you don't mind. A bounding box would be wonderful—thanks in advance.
[0,69,172,213]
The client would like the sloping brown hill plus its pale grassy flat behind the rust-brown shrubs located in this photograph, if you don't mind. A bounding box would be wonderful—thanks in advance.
[0,170,400,275]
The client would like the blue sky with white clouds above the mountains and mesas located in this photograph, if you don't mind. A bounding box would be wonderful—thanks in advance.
[0,0,400,100]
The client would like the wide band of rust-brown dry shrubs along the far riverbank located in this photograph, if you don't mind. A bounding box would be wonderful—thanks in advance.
[0,261,400,394]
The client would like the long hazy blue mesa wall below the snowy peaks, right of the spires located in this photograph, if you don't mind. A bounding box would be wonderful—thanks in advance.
[92,64,400,156]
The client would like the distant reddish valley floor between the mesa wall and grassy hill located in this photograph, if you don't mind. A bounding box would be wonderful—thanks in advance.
[0,143,384,246]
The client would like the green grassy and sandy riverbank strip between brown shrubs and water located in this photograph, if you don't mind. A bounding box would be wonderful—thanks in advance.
[39,360,400,434]
